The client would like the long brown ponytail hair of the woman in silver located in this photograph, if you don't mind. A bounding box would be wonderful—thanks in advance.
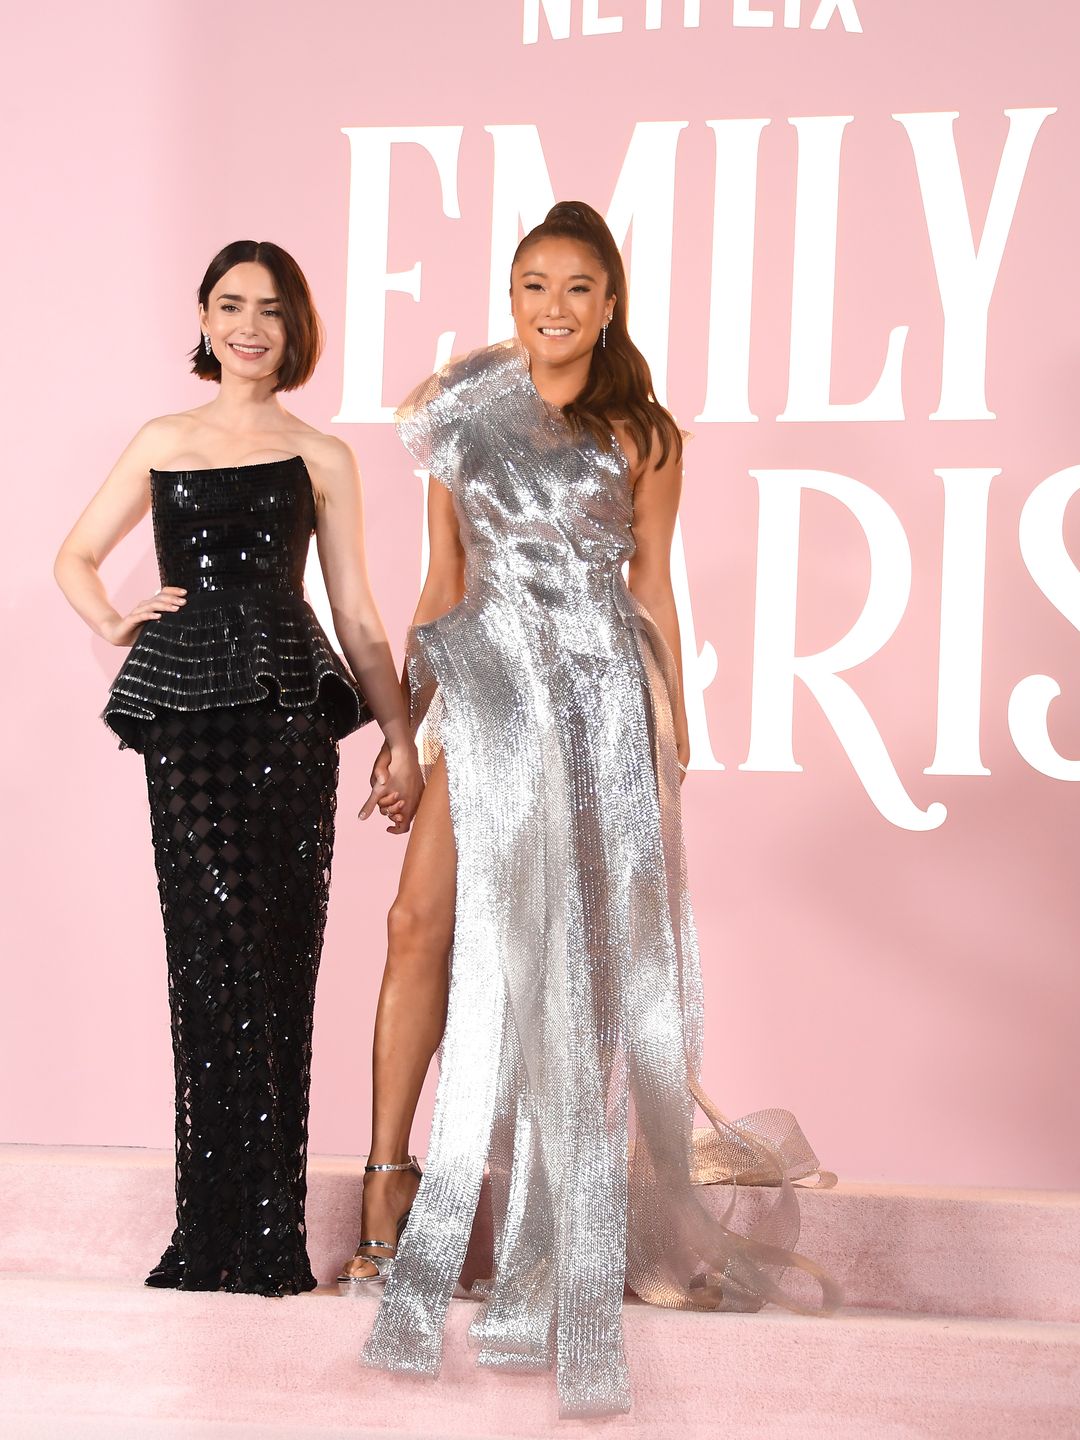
[511,200,683,465]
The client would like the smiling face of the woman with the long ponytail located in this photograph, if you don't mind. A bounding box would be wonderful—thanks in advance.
[510,236,615,366]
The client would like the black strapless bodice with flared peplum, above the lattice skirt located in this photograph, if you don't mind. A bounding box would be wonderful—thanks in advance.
[102,455,372,750]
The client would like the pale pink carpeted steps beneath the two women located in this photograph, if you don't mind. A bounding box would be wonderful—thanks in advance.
[0,1146,1080,1440]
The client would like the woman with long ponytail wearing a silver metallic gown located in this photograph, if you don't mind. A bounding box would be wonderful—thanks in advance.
[343,203,834,1414]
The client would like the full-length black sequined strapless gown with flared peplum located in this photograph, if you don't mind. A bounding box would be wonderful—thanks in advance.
[104,456,370,1295]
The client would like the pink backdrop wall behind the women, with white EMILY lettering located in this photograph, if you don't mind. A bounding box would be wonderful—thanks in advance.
[0,0,1080,1187]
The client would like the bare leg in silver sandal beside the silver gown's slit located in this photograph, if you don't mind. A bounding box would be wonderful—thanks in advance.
[347,756,458,1276]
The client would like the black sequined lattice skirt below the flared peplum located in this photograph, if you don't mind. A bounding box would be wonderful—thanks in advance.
[143,701,337,1295]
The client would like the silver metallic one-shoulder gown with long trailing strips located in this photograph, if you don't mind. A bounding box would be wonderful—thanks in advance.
[364,343,834,1414]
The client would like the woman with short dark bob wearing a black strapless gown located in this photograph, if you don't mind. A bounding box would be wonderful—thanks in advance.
[56,240,422,1295]
